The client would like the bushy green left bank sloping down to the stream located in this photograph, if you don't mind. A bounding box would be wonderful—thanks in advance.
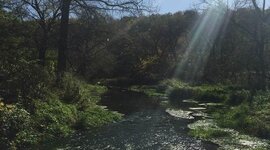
[0,74,122,149]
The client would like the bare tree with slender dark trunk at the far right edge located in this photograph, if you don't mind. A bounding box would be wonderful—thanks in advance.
[229,0,270,89]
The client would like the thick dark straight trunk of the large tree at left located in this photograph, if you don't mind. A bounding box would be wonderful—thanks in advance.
[57,0,71,80]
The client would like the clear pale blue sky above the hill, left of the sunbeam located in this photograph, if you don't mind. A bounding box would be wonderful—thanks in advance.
[156,0,270,14]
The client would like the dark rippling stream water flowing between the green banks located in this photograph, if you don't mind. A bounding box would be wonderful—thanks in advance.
[40,89,218,150]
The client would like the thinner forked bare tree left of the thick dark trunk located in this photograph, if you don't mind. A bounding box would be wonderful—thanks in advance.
[3,0,60,66]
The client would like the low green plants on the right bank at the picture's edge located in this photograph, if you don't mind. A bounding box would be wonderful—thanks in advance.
[214,99,270,138]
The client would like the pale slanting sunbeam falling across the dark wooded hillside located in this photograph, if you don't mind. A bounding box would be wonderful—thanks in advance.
[174,1,230,81]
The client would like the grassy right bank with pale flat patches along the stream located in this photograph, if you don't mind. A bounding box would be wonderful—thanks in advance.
[131,80,270,149]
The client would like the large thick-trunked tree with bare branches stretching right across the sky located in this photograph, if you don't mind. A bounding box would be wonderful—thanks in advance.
[57,0,155,80]
